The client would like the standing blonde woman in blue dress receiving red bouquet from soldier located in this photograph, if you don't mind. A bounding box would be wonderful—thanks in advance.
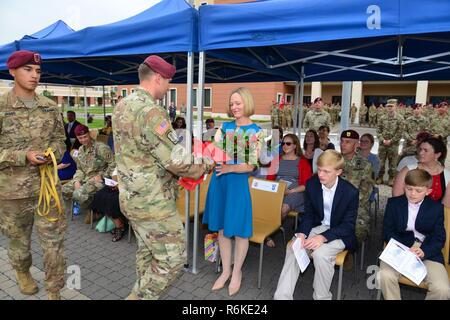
[203,88,264,296]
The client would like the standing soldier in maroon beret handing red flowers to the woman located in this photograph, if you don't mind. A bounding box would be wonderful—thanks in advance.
[113,56,212,300]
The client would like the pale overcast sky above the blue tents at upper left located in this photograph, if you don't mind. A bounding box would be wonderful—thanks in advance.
[0,0,160,45]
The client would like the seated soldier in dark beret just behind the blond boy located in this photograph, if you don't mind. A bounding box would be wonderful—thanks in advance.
[341,130,374,243]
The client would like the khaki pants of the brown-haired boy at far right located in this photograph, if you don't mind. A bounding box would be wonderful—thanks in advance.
[380,260,450,300]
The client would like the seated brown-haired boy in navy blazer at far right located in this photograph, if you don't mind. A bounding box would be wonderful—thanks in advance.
[380,169,450,300]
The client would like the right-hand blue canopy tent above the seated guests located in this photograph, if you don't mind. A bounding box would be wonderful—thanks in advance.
[199,0,450,81]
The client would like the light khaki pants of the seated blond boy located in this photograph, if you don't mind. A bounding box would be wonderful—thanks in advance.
[274,226,345,300]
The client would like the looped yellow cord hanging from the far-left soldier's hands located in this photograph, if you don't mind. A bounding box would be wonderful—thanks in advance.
[37,148,63,222]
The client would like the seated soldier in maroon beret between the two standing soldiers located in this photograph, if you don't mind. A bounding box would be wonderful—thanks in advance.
[63,124,116,208]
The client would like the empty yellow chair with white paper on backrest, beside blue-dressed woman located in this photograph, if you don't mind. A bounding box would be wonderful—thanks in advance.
[249,177,286,289]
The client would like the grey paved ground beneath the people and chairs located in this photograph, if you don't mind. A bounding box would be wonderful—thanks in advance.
[0,182,424,300]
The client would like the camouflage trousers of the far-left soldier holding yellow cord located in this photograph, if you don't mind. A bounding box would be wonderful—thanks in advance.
[0,198,67,292]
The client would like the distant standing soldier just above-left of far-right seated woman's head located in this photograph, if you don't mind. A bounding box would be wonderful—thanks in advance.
[399,104,429,160]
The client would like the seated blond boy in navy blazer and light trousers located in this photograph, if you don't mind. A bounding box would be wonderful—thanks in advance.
[274,150,359,300]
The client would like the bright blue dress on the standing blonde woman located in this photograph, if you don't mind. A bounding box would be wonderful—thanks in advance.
[203,121,261,238]
